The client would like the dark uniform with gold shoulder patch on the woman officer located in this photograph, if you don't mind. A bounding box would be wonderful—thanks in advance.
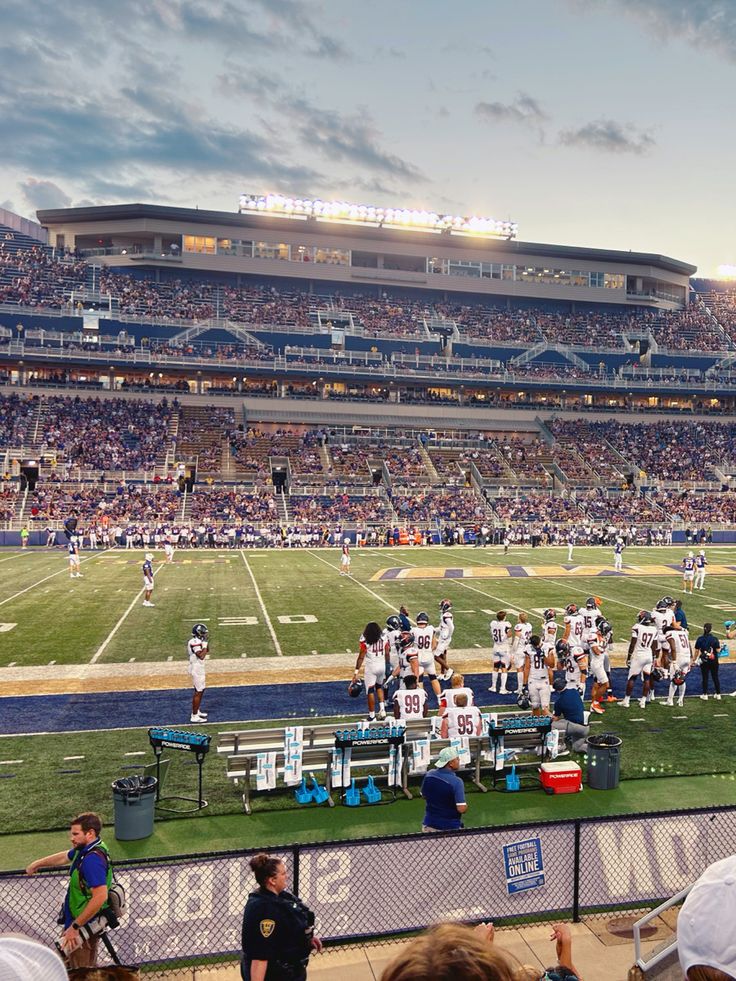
[242,888,314,981]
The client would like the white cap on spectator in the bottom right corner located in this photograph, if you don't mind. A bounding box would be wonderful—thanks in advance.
[677,855,736,977]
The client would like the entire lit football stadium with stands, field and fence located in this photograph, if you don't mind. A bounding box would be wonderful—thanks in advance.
[0,188,736,979]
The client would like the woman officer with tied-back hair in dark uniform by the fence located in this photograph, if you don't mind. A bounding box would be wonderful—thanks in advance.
[241,852,322,981]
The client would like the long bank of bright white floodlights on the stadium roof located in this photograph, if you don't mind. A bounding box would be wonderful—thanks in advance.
[239,194,519,239]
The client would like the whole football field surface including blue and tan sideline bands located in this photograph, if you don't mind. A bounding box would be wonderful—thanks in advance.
[0,546,736,848]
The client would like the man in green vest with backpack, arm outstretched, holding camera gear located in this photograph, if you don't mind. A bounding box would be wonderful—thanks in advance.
[26,814,112,968]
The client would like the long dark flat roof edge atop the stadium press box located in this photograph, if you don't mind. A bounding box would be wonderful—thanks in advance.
[36,204,698,276]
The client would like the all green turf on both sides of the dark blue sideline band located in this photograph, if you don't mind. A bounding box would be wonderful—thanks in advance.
[0,546,736,856]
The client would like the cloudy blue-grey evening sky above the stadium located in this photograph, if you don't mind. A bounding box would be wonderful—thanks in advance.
[0,0,736,276]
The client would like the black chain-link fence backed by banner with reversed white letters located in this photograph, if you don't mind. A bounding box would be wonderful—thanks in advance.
[0,807,736,968]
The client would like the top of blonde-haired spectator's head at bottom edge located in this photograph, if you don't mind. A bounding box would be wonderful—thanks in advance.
[381,923,524,981]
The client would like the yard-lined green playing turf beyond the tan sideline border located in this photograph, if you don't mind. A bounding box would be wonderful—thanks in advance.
[0,546,736,666]
